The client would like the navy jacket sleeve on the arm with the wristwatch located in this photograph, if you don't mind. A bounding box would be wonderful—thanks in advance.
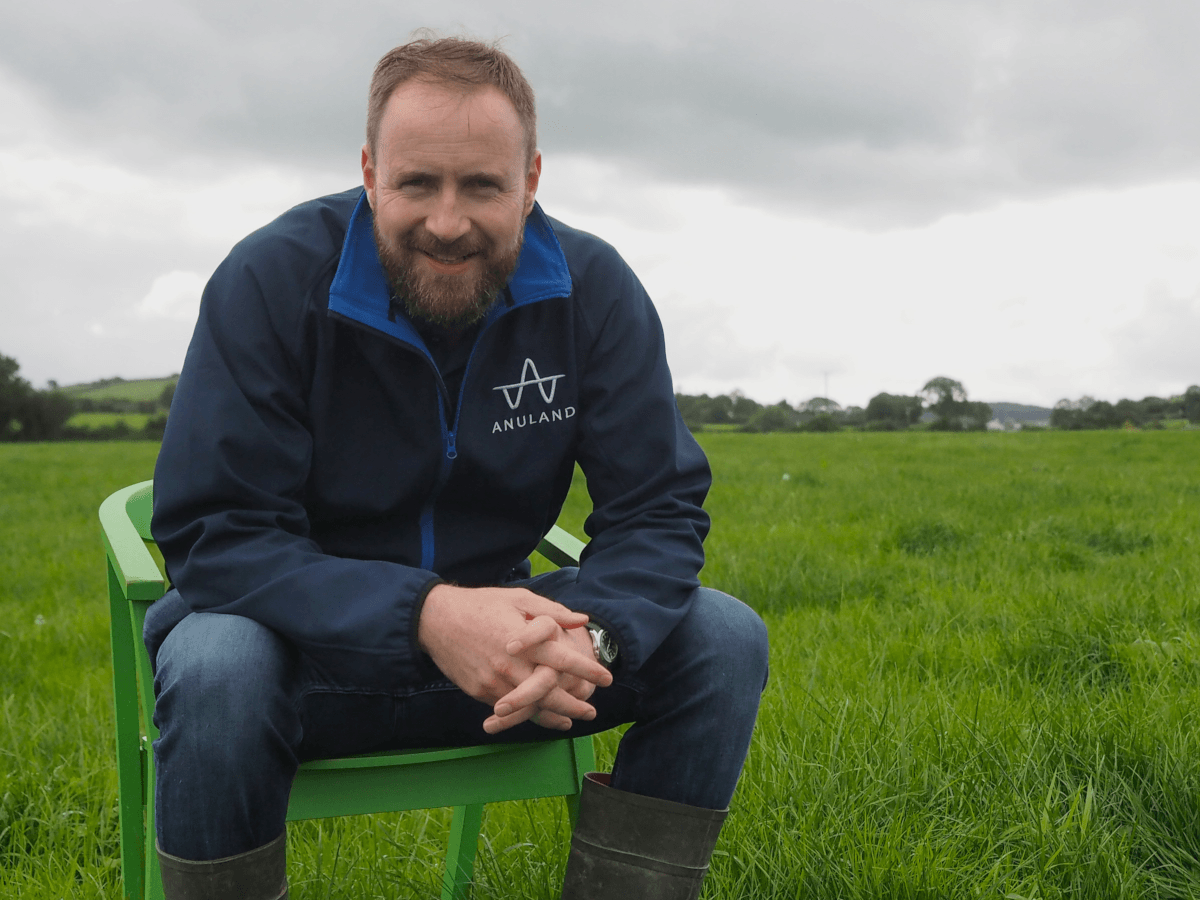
[557,248,712,671]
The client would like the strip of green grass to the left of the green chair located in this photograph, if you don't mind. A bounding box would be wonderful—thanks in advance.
[0,443,158,900]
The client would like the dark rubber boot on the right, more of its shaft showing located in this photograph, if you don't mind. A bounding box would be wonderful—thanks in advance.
[563,772,728,900]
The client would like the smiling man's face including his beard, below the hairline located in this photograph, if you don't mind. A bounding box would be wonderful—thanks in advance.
[362,79,541,326]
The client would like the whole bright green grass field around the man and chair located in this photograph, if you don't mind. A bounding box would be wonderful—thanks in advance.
[0,432,1200,900]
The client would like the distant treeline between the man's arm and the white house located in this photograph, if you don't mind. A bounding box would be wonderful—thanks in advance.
[676,376,991,432]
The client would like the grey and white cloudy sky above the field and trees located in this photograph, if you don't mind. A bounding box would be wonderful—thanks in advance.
[0,0,1200,406]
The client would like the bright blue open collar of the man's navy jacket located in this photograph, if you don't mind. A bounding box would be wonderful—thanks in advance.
[329,191,571,347]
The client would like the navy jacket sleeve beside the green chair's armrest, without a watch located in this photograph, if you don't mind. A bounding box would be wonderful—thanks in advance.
[151,243,438,684]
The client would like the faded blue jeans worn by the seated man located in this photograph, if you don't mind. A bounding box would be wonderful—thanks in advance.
[144,569,767,859]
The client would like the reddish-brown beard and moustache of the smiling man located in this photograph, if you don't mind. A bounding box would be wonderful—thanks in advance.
[372,217,524,330]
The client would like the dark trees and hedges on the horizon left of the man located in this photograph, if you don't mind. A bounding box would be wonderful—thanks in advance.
[0,354,175,442]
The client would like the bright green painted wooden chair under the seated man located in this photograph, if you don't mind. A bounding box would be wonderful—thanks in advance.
[100,481,595,900]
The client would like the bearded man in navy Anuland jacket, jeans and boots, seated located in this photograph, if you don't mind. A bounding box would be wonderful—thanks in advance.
[145,38,767,900]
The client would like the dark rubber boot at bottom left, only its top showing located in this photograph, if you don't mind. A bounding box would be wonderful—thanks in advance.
[158,830,288,900]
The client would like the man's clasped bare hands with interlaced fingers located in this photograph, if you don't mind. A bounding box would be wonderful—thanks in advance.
[416,584,612,734]
